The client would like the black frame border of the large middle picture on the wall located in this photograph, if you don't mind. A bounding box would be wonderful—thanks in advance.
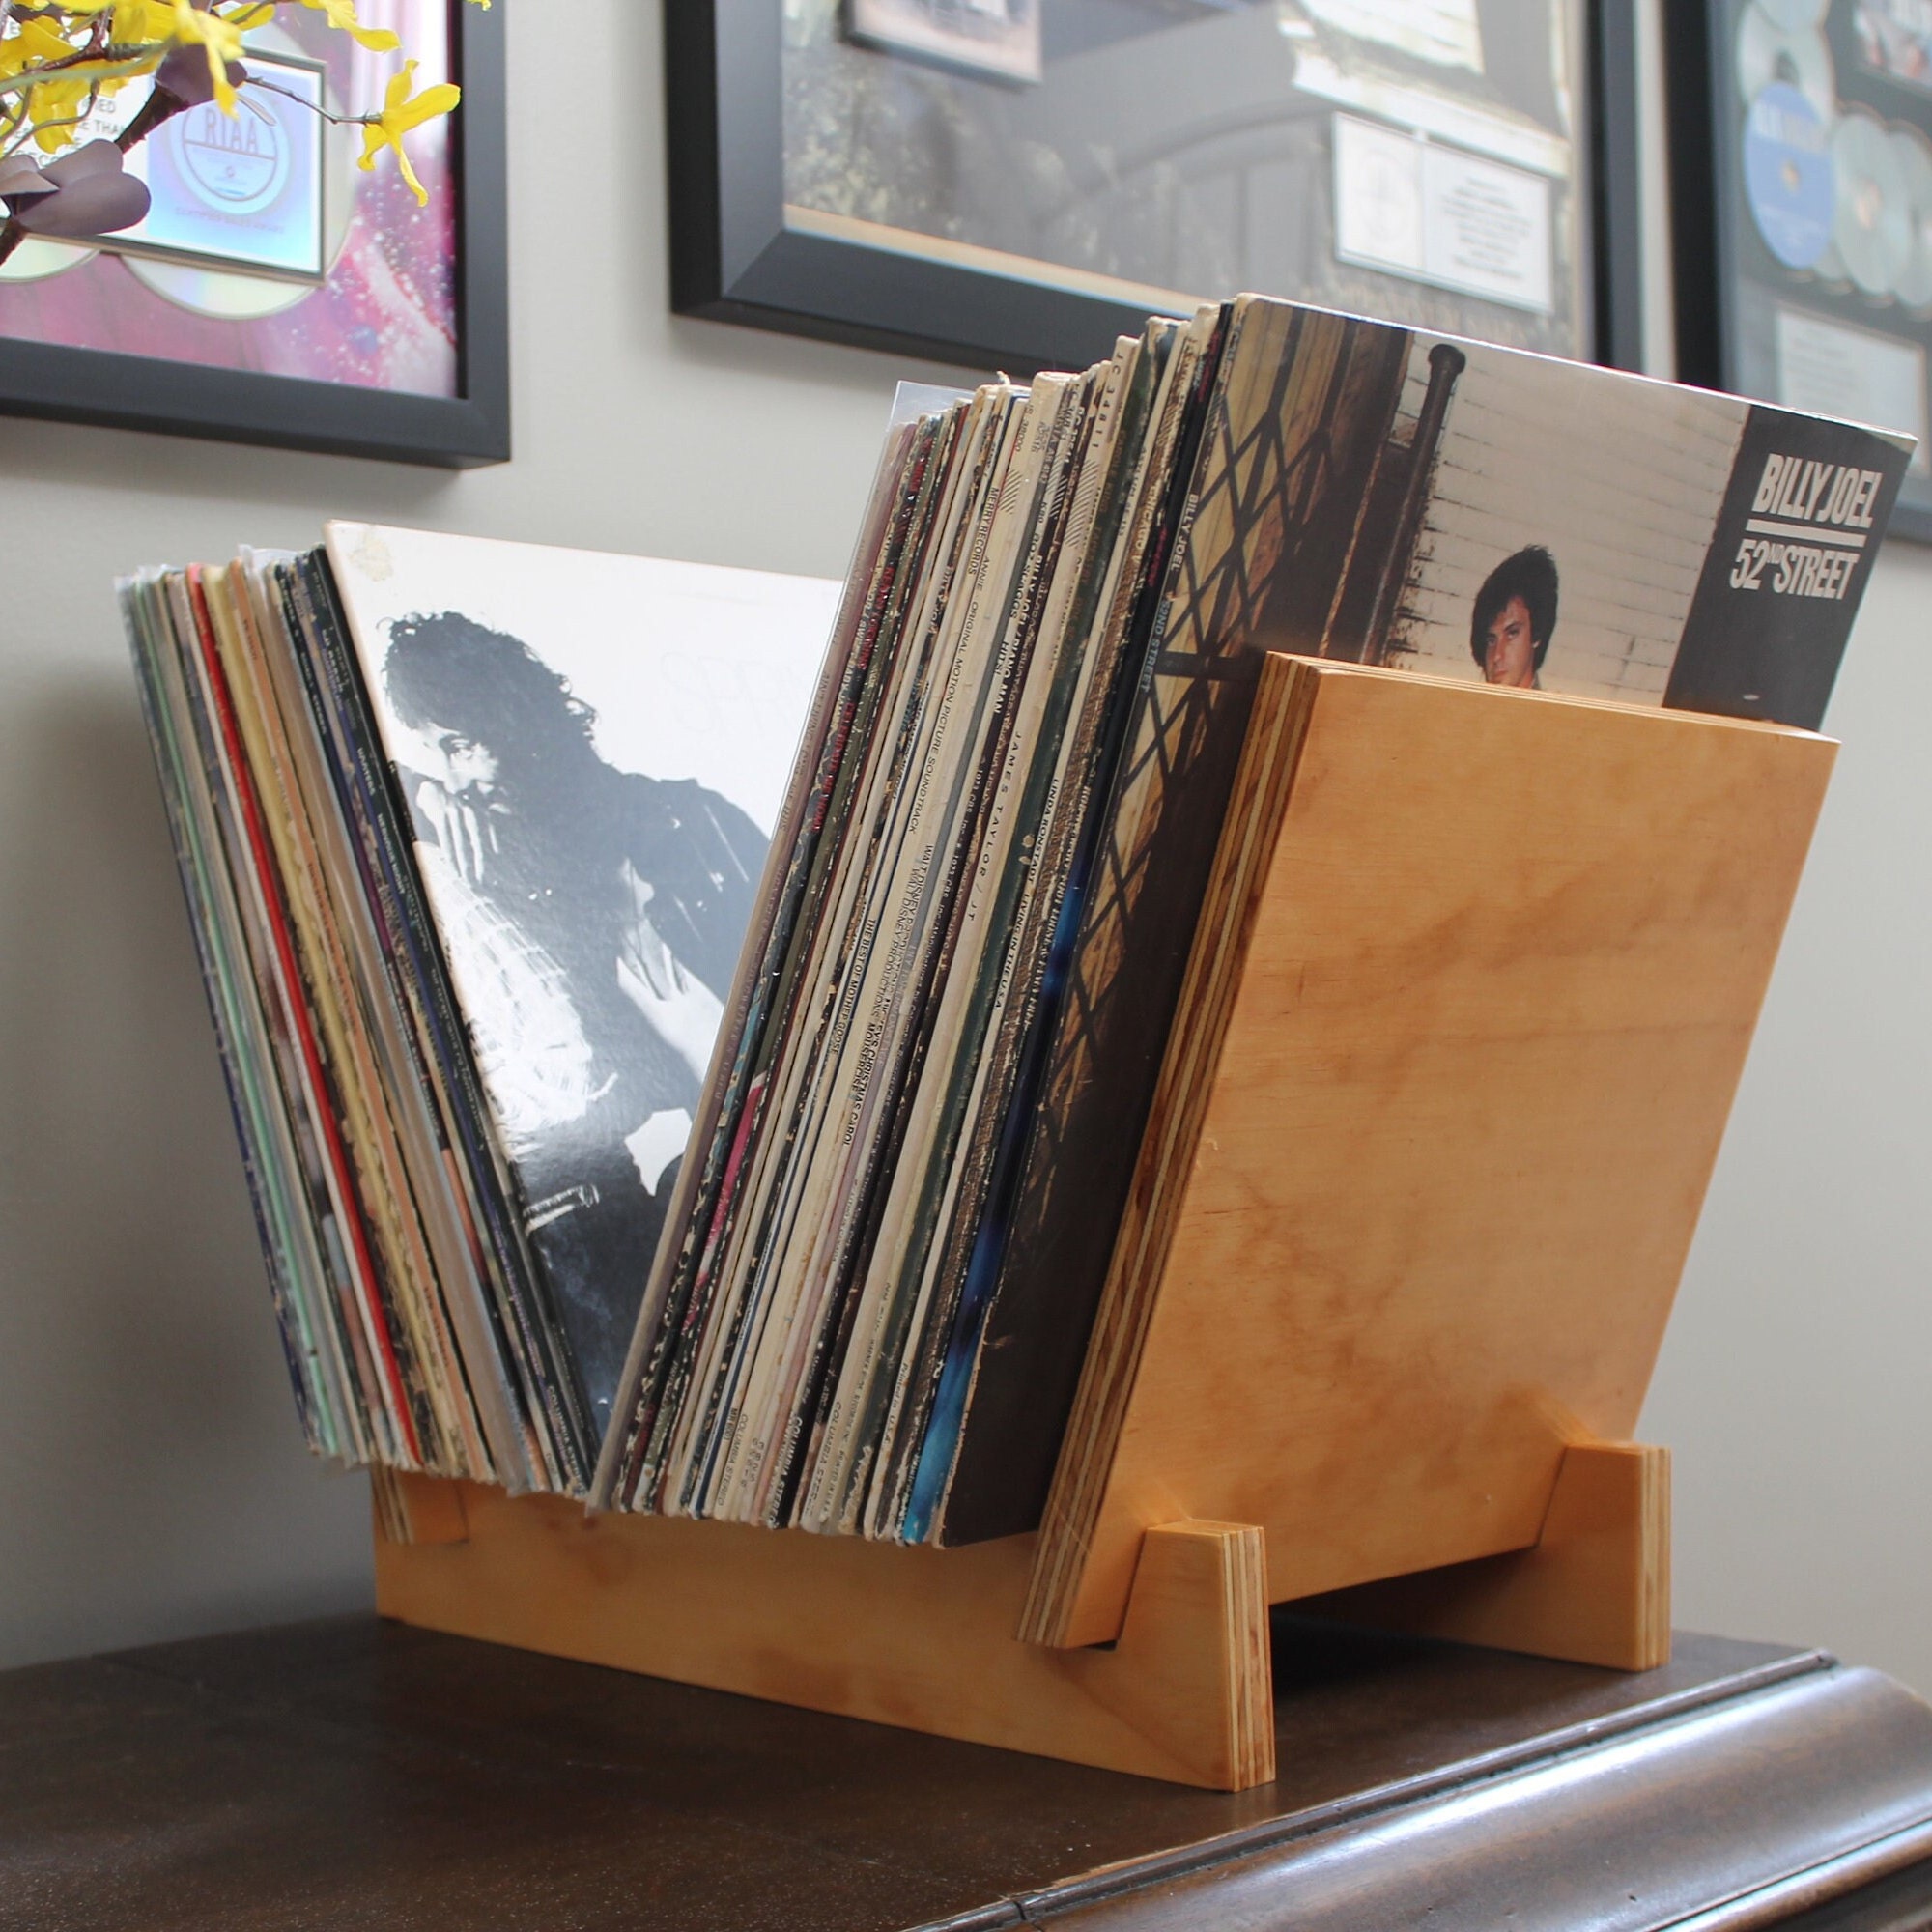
[665,0,1642,373]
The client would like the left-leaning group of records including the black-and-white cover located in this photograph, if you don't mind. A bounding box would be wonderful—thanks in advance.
[122,526,835,1492]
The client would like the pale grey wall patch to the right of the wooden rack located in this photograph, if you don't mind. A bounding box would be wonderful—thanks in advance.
[1642,545,1932,1692]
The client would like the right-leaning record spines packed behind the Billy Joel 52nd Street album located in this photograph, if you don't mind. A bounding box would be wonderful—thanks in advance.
[603,309,1219,1538]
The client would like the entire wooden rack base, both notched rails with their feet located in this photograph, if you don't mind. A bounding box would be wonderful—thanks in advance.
[375,1445,1669,1791]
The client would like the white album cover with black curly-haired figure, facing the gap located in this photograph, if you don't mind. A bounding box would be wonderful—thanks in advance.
[328,524,838,1424]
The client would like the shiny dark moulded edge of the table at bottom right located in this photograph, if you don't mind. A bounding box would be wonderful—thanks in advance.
[925,1652,1932,1932]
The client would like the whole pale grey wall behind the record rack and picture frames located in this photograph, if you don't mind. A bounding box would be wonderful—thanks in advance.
[0,0,1932,1690]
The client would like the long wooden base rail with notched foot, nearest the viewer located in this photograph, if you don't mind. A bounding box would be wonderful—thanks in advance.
[375,1476,1275,1791]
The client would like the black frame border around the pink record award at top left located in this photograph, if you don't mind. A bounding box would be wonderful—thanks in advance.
[0,0,510,469]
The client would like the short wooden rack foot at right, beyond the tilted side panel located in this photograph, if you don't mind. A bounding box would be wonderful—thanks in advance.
[1294,1443,1671,1671]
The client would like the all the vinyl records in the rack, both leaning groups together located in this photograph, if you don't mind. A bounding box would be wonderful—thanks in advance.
[124,296,1907,1544]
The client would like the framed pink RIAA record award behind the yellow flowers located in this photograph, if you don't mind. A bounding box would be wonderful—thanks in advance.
[0,0,510,466]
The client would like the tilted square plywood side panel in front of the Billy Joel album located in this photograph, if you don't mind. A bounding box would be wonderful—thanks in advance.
[1022,663,1833,1644]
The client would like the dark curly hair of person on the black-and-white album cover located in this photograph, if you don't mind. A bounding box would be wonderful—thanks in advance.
[383,611,597,763]
